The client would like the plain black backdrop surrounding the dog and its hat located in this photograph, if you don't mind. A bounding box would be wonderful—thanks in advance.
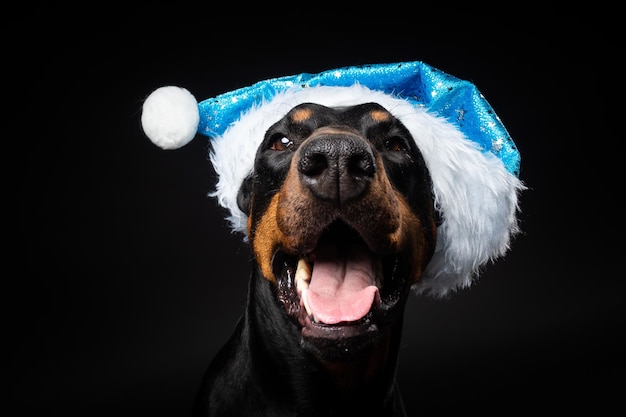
[12,2,624,416]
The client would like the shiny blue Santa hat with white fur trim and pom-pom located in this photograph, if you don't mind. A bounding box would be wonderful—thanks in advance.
[141,62,525,296]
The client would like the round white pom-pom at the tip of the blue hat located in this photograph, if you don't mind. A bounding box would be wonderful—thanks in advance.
[141,86,200,149]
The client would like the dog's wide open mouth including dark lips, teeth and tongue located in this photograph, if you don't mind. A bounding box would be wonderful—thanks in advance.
[272,220,408,352]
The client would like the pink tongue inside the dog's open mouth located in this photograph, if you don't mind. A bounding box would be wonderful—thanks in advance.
[301,242,378,324]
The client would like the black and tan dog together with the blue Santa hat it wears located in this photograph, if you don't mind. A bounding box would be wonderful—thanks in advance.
[142,61,525,417]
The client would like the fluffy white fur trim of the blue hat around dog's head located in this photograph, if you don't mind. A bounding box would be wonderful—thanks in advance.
[210,85,524,296]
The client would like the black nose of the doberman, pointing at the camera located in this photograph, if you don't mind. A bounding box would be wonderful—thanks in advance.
[298,134,376,205]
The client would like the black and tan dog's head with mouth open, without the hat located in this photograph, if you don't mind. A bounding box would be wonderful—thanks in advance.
[238,103,436,358]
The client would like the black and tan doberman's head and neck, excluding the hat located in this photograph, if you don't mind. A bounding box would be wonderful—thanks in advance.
[194,103,436,417]
